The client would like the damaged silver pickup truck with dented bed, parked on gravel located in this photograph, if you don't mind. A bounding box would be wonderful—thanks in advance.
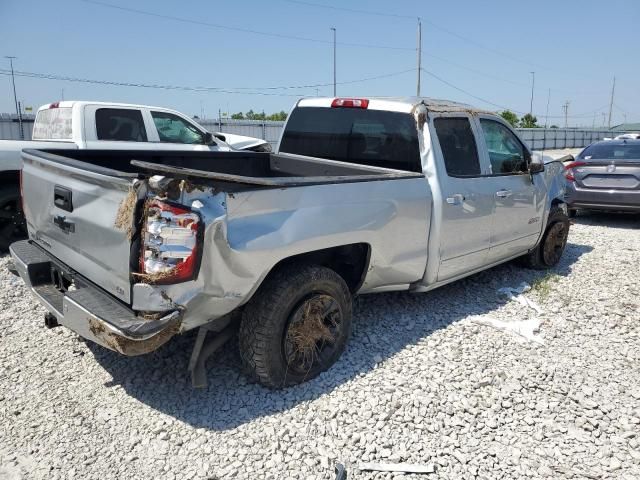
[10,98,569,388]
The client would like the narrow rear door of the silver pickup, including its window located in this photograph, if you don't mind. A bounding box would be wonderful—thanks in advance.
[432,114,495,281]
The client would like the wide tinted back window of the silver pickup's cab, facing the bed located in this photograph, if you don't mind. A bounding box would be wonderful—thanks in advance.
[280,107,422,172]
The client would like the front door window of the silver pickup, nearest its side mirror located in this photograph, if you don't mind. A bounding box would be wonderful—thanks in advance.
[480,119,528,175]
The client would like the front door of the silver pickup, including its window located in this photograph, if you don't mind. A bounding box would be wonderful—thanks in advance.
[478,116,546,263]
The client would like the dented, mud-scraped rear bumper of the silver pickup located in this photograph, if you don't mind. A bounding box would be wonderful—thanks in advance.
[9,240,181,355]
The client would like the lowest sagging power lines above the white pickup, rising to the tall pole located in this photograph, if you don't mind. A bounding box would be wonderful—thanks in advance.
[0,68,416,97]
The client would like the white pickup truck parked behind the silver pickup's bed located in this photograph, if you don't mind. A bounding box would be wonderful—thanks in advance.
[0,101,270,251]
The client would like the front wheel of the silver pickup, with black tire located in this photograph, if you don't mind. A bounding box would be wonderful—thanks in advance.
[522,206,569,270]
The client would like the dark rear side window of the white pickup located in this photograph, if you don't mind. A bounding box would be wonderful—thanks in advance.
[96,108,147,142]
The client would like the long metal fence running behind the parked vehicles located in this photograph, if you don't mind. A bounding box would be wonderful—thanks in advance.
[0,113,624,150]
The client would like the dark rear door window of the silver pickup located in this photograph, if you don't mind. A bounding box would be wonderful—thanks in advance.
[433,118,480,177]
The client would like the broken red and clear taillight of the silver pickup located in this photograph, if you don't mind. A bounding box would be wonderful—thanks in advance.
[139,200,200,284]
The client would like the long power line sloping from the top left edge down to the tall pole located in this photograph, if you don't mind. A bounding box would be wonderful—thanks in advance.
[80,0,415,51]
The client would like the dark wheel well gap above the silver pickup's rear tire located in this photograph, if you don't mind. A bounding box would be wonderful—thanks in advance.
[265,243,371,293]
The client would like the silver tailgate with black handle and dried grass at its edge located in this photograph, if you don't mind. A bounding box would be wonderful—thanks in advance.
[22,151,136,303]
